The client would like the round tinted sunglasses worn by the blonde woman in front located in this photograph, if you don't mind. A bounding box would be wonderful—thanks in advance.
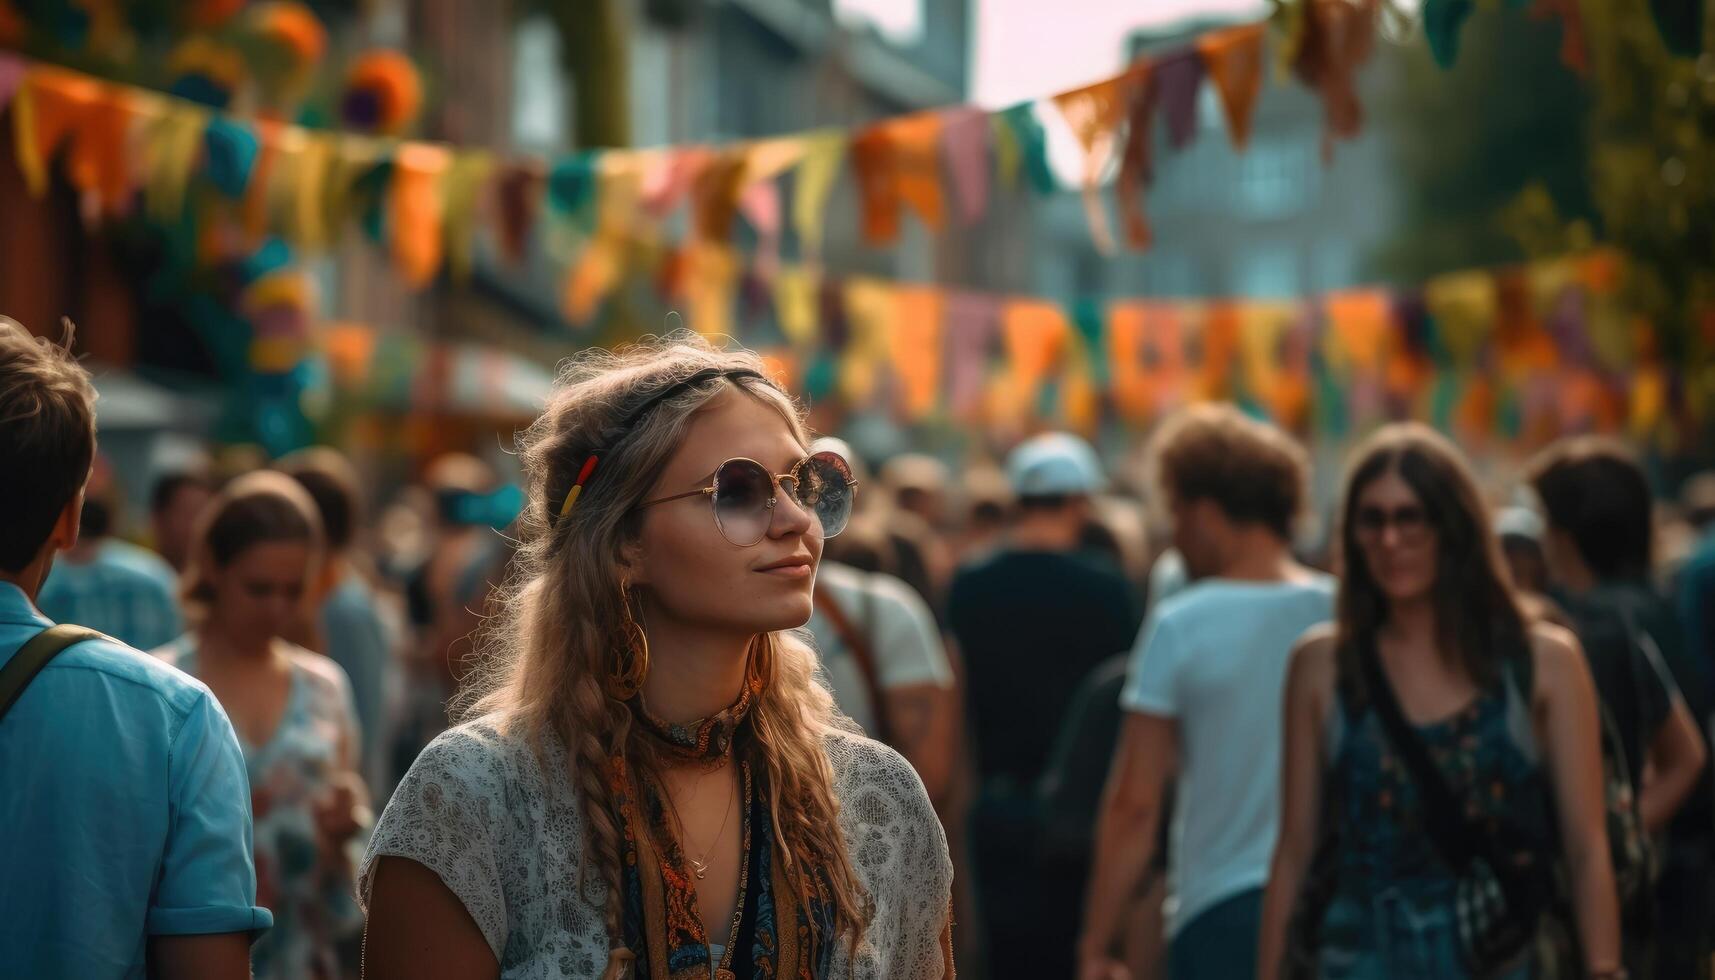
[638,453,858,547]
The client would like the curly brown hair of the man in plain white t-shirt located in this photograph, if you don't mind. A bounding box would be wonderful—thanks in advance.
[1149,405,1310,541]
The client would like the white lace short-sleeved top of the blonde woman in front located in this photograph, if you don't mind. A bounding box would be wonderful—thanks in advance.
[358,719,954,980]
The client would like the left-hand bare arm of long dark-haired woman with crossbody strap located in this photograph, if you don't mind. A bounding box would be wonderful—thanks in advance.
[1257,630,1334,980]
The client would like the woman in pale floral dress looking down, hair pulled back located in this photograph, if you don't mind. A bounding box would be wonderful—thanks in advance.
[156,472,370,978]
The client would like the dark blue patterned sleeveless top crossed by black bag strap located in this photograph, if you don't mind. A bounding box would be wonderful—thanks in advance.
[1324,654,1557,896]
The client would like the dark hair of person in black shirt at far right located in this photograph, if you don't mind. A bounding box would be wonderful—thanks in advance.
[1530,436,1655,578]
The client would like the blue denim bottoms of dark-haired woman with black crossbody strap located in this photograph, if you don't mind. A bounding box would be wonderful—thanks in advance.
[1317,886,1531,980]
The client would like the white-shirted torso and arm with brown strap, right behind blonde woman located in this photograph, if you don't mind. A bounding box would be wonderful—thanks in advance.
[809,561,955,800]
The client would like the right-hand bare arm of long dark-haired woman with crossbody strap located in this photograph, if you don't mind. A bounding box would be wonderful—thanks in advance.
[1533,625,1621,973]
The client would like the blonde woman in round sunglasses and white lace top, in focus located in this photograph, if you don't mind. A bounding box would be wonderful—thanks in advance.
[360,338,952,980]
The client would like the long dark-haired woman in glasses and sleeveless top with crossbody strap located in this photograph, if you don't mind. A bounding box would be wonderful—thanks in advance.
[1259,424,1626,980]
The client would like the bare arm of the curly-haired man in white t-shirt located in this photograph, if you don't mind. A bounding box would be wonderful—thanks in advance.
[1079,712,1178,978]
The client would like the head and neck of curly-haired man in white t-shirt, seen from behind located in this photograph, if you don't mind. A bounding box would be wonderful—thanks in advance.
[1149,403,1310,577]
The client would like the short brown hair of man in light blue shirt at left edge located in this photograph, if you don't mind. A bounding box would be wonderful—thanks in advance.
[0,316,96,573]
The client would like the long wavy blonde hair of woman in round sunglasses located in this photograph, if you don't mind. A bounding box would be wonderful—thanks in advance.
[454,335,871,977]
